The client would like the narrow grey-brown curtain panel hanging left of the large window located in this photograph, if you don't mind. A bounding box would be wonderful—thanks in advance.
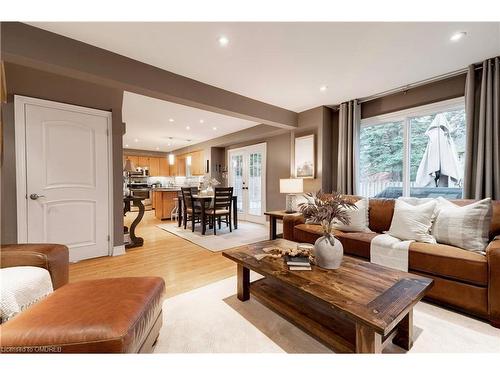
[336,100,361,194]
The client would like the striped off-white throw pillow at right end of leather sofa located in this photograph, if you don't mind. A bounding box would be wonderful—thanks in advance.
[432,197,492,252]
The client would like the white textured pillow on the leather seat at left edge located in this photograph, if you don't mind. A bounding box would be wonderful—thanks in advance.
[0,266,53,322]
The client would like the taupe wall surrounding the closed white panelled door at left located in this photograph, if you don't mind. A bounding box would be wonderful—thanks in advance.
[1,63,124,246]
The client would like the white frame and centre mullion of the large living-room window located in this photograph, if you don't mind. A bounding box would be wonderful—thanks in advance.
[356,96,465,197]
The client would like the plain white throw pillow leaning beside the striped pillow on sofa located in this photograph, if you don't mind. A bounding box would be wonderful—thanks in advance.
[387,199,436,243]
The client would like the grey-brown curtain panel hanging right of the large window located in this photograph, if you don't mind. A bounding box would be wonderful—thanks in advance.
[464,57,500,199]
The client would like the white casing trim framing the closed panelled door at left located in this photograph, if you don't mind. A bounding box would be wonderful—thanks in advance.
[14,95,114,255]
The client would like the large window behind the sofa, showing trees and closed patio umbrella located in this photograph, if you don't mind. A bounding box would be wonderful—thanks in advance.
[358,98,465,199]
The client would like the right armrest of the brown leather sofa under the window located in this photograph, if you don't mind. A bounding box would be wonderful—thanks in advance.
[486,239,500,328]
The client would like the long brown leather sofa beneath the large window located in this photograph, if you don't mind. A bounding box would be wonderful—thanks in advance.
[283,197,500,328]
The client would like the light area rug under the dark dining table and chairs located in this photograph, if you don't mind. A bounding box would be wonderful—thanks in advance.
[157,221,269,252]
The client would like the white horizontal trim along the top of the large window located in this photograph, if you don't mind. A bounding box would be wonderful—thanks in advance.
[361,96,465,126]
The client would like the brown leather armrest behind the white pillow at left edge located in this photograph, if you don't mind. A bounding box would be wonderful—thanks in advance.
[0,244,69,289]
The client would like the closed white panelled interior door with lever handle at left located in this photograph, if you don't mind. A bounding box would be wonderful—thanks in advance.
[15,97,111,261]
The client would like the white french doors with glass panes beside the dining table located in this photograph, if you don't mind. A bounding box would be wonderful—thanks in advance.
[228,143,266,224]
